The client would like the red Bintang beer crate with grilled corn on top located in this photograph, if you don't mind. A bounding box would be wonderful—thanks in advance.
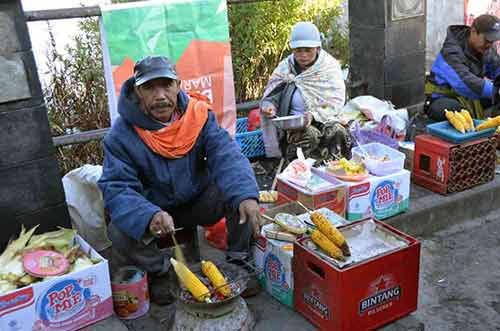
[293,220,420,331]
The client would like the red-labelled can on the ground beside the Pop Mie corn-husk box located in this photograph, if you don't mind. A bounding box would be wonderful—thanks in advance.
[111,266,149,319]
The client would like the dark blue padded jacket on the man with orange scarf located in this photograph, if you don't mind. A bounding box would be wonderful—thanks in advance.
[98,78,258,240]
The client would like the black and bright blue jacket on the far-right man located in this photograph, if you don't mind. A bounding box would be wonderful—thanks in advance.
[430,25,500,100]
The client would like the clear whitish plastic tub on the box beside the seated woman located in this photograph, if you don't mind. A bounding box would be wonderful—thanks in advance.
[352,143,405,176]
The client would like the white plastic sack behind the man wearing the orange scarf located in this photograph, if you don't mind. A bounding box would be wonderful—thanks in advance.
[62,164,111,251]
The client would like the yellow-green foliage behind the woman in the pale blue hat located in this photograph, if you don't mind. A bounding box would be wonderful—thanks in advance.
[229,0,348,102]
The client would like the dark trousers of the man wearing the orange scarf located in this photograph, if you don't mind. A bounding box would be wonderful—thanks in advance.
[108,185,252,274]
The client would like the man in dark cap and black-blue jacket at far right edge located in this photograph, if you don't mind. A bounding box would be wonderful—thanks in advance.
[425,15,500,121]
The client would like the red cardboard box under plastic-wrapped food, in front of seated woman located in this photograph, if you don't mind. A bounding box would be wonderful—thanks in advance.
[276,174,346,217]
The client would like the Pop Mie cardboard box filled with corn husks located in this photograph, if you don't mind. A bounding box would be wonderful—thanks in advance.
[0,236,113,331]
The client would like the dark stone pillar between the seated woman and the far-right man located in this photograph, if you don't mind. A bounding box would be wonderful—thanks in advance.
[349,0,426,112]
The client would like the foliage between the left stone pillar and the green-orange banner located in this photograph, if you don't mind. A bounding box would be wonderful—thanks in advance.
[44,18,110,174]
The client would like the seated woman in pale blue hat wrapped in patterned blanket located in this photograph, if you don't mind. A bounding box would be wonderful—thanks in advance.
[260,22,351,162]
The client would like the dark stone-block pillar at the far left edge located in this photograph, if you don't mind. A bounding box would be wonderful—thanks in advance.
[0,0,70,251]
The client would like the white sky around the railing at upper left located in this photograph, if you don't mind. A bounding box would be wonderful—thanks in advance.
[21,0,108,80]
